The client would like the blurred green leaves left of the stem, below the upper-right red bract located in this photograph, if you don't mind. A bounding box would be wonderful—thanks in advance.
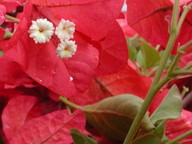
[127,36,162,76]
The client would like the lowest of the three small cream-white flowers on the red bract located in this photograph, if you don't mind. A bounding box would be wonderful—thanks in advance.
[56,40,77,58]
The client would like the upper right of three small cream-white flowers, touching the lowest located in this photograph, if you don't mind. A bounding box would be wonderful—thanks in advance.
[55,19,75,41]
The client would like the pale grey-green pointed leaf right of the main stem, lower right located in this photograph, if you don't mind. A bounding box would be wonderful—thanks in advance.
[150,85,182,123]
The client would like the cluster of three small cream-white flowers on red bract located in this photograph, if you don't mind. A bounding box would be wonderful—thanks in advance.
[29,19,77,58]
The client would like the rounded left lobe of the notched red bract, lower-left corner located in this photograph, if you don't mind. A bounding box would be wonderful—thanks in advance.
[2,96,37,141]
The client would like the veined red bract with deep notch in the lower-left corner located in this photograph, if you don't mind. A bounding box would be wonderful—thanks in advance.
[2,96,85,144]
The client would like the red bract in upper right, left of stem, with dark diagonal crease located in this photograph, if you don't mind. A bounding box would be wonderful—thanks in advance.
[127,0,173,46]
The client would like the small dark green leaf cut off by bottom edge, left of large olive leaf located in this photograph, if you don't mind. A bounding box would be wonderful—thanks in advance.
[70,129,97,144]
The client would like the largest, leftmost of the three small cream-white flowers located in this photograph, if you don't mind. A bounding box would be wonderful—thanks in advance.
[29,19,54,43]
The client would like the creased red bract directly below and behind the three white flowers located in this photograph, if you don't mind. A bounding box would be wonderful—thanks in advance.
[5,3,99,97]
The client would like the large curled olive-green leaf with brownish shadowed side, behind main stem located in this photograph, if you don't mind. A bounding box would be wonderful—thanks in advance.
[82,94,154,141]
